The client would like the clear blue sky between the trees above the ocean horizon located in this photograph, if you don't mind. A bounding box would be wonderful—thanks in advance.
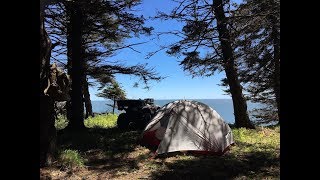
[89,0,231,101]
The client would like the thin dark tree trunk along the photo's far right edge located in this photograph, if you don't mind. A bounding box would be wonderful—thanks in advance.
[271,16,280,123]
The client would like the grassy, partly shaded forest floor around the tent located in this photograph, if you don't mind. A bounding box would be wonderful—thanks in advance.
[40,116,280,180]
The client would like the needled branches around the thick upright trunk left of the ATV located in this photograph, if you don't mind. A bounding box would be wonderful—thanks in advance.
[45,0,162,89]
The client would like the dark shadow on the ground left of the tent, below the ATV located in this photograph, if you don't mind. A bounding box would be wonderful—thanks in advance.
[58,127,146,174]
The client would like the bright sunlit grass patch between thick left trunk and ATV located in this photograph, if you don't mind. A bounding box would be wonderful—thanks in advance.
[84,114,118,128]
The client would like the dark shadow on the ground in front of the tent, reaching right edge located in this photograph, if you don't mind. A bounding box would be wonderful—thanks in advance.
[151,149,280,180]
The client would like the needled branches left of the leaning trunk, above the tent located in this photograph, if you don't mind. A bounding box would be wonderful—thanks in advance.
[156,0,224,77]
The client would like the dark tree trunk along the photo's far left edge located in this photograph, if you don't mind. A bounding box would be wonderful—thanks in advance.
[40,1,56,166]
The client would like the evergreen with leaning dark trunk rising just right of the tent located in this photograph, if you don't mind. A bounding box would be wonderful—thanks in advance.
[157,0,254,128]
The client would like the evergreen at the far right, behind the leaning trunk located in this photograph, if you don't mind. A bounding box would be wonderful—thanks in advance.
[231,0,280,123]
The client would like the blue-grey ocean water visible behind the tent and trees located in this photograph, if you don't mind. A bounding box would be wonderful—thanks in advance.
[92,99,260,123]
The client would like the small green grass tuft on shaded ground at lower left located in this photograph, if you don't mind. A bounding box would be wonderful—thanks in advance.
[58,149,84,169]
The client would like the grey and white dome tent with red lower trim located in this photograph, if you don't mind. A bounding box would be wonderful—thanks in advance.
[141,100,234,155]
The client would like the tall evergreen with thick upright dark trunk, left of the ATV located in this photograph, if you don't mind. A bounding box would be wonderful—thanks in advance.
[47,0,161,131]
